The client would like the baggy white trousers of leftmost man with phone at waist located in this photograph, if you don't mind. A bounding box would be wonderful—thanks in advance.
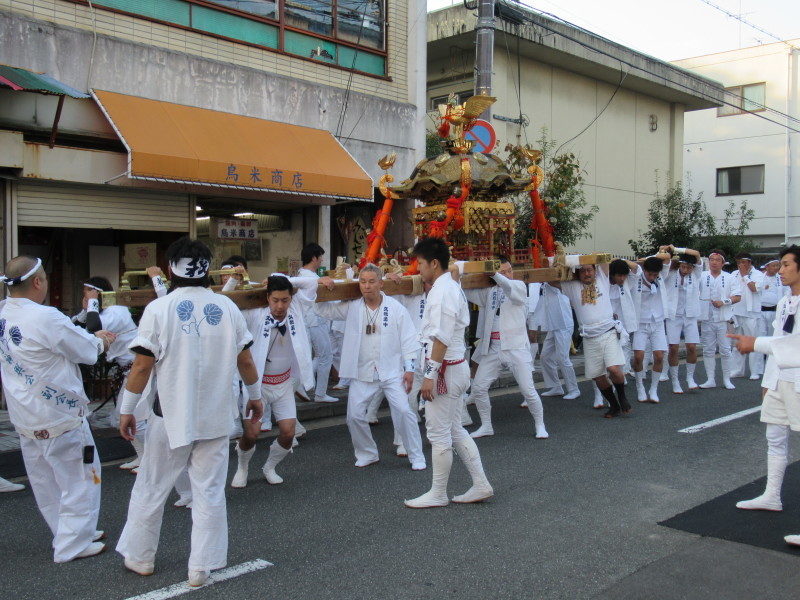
[20,419,100,563]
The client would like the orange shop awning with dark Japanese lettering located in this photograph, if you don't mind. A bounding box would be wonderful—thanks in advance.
[92,90,373,202]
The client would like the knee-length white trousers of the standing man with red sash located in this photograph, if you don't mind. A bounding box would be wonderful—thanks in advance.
[425,353,472,448]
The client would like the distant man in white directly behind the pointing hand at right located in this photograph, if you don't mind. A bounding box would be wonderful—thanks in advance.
[731,252,766,381]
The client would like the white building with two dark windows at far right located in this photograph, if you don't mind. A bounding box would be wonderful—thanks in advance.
[675,39,800,251]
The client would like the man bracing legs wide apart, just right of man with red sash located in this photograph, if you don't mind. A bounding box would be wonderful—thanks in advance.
[464,257,550,439]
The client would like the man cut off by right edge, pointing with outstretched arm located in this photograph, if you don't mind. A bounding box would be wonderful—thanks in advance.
[730,245,800,546]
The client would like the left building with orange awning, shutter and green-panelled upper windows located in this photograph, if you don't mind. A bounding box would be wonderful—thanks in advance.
[0,0,425,310]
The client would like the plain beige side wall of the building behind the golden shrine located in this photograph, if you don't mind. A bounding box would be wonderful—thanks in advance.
[429,47,683,255]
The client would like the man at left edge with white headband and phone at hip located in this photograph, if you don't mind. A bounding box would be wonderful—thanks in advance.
[0,256,115,563]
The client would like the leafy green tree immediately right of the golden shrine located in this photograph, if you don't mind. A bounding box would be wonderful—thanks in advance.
[505,128,599,248]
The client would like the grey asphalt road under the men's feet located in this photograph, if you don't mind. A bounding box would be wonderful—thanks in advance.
[0,369,800,600]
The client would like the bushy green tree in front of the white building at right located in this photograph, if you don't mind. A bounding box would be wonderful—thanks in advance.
[628,182,756,257]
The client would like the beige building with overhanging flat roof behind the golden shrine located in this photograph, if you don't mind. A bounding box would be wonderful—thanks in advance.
[428,3,723,255]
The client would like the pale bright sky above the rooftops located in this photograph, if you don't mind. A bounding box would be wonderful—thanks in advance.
[428,0,800,61]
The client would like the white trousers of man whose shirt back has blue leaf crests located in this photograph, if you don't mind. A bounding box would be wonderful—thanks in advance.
[117,415,229,571]
